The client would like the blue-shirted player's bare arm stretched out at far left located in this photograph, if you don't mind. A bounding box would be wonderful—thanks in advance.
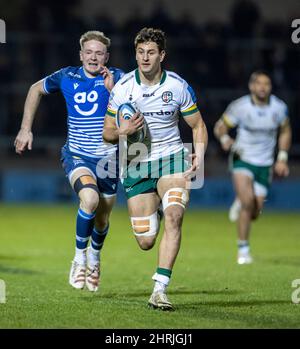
[14,80,46,155]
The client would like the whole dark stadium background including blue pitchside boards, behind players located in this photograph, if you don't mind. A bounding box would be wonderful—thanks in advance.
[0,0,300,210]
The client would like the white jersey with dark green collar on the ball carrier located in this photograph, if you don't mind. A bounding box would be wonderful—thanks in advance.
[107,69,198,162]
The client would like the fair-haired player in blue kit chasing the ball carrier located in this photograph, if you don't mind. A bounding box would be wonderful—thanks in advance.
[14,31,123,291]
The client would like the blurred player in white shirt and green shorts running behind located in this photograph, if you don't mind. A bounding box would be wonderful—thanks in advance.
[214,71,292,264]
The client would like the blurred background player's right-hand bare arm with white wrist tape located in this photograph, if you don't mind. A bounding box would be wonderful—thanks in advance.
[274,119,292,177]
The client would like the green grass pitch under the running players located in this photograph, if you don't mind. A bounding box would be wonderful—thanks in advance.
[0,205,300,329]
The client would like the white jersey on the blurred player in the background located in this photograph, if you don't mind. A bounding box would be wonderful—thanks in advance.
[223,95,288,166]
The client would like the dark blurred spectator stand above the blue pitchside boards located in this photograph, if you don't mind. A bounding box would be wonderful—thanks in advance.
[0,0,300,173]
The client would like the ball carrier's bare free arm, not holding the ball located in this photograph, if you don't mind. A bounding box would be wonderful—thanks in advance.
[184,111,208,177]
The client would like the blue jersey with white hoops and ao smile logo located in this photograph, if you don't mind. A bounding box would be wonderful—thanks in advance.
[44,67,124,158]
